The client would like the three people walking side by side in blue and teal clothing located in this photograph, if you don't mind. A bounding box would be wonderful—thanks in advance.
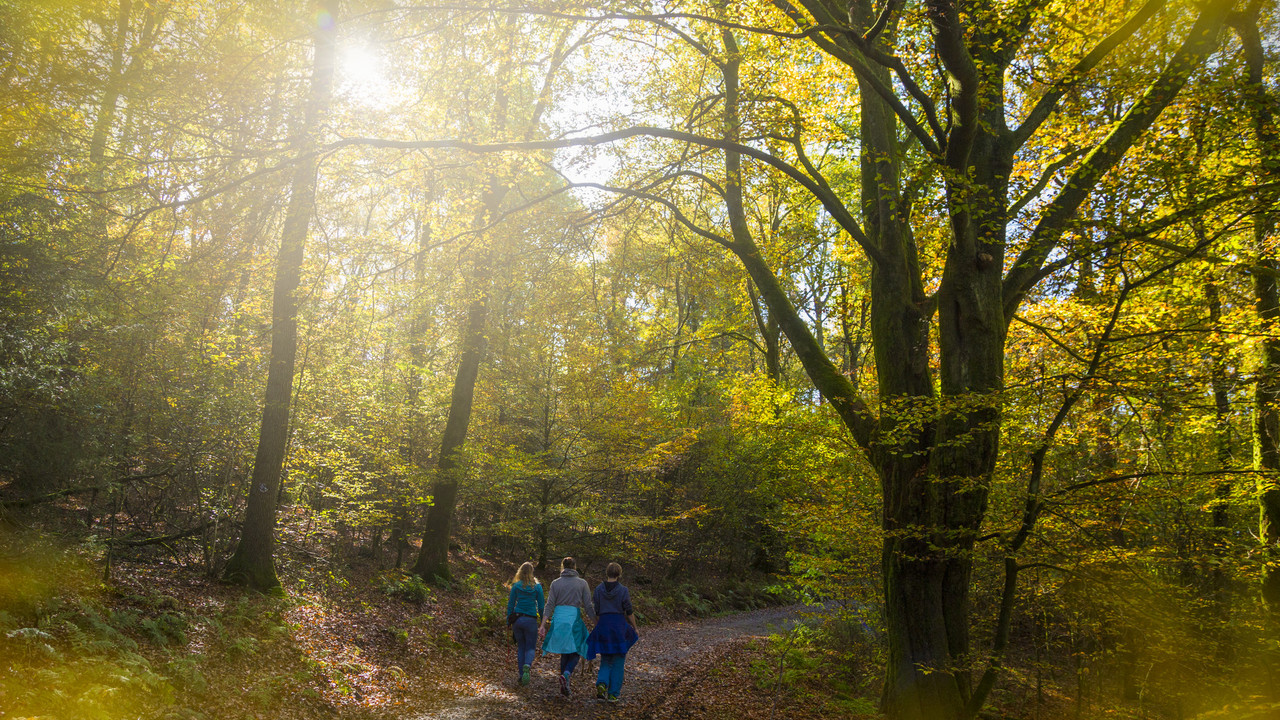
[507,557,640,702]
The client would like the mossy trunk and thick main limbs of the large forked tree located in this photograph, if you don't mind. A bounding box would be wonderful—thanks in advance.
[722,0,1231,720]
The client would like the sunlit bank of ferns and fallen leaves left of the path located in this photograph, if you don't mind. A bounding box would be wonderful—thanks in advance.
[0,537,504,720]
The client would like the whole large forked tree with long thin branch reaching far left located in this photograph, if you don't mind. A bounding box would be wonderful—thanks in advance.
[344,0,1234,720]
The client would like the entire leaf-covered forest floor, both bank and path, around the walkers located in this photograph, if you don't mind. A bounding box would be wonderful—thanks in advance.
[0,538,876,720]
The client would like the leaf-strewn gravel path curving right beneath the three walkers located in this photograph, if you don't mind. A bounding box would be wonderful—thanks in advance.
[416,605,818,720]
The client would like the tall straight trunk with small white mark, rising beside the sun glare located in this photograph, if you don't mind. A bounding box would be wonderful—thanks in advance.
[223,0,338,589]
